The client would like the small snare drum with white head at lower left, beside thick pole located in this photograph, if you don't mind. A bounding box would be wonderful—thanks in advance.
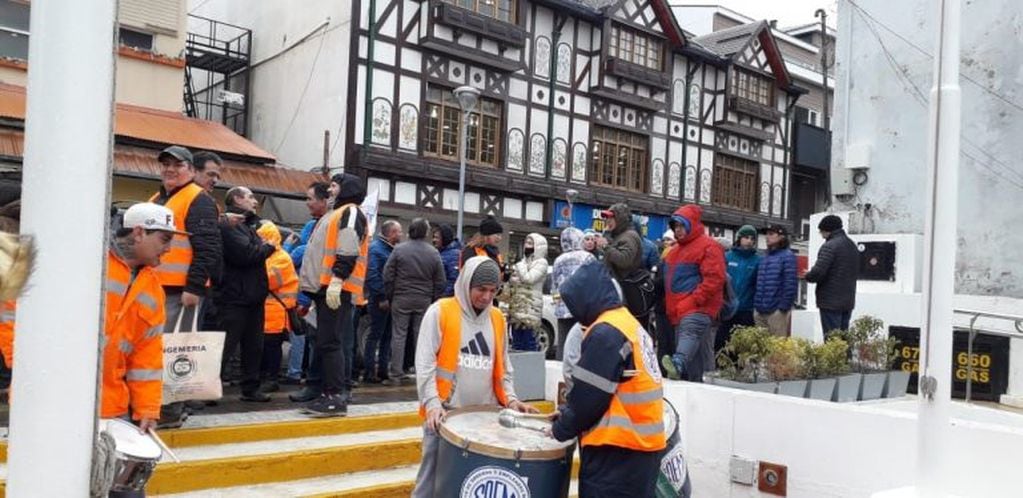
[99,418,162,491]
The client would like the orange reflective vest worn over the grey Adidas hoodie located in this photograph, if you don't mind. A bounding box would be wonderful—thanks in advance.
[419,298,508,418]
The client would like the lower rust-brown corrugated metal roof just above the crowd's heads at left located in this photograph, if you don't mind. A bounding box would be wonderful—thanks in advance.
[0,128,322,198]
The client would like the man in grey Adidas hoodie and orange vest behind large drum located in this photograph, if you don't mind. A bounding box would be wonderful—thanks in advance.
[412,256,538,498]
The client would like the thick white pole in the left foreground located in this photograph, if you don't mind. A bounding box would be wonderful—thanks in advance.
[6,0,117,498]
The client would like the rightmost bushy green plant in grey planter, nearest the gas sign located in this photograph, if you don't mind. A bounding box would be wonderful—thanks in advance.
[846,316,898,400]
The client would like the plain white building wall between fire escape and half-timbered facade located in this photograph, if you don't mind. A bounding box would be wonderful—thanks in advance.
[190,0,352,170]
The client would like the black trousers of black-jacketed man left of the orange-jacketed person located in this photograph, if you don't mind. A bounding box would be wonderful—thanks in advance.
[217,303,264,393]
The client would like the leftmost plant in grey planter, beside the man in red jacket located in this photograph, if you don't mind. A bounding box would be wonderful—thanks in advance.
[708,326,777,393]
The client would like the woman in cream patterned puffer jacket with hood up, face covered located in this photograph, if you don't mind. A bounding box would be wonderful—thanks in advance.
[508,233,547,351]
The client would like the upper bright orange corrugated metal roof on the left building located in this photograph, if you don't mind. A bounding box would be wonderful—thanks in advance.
[0,83,276,164]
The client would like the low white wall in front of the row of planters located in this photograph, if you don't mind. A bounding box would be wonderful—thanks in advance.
[547,362,1023,498]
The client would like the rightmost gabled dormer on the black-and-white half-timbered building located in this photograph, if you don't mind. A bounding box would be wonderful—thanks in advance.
[694,21,792,123]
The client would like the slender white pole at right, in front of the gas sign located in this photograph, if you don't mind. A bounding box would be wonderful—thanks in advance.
[917,0,962,496]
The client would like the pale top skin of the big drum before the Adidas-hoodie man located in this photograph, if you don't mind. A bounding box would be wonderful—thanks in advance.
[440,406,573,460]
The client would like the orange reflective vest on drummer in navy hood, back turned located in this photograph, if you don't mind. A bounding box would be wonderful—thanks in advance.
[580,307,665,451]
